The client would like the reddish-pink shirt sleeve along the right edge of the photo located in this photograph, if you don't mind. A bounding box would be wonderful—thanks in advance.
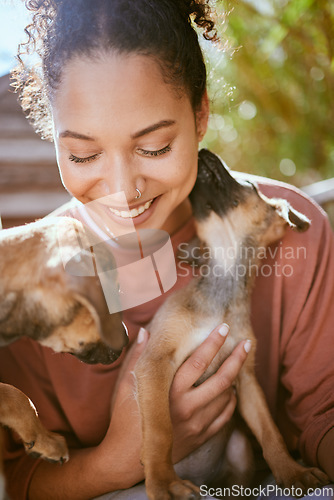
[280,194,334,465]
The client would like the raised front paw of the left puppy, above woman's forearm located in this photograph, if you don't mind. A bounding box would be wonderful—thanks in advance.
[25,431,69,464]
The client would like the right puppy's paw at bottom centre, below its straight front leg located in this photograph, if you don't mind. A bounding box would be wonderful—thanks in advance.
[146,477,201,500]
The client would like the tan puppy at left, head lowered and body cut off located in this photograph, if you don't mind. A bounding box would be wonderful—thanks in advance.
[0,217,127,498]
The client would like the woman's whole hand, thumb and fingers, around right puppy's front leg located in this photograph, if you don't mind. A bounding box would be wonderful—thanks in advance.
[99,325,247,488]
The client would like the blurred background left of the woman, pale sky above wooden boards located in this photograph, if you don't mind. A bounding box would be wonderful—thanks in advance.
[0,0,70,227]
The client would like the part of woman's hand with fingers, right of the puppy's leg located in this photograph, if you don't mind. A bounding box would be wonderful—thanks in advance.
[170,325,250,463]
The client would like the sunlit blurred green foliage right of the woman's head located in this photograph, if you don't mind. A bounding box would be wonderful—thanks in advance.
[203,0,334,185]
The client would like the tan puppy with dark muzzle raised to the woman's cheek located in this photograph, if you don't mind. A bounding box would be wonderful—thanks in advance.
[135,150,328,500]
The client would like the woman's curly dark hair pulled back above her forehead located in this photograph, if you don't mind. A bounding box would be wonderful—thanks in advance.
[12,0,218,140]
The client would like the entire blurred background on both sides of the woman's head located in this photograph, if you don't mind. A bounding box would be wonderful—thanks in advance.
[0,0,334,226]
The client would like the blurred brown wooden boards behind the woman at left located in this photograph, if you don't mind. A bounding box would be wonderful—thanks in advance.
[0,75,70,227]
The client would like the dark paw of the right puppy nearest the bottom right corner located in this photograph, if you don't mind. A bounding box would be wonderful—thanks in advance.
[281,464,330,496]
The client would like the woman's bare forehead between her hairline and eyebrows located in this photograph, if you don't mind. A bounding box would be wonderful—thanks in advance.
[52,53,191,130]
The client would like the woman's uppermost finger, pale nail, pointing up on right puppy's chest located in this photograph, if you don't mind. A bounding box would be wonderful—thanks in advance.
[173,323,229,391]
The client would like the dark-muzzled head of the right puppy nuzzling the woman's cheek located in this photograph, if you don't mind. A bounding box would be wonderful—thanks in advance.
[190,149,310,246]
